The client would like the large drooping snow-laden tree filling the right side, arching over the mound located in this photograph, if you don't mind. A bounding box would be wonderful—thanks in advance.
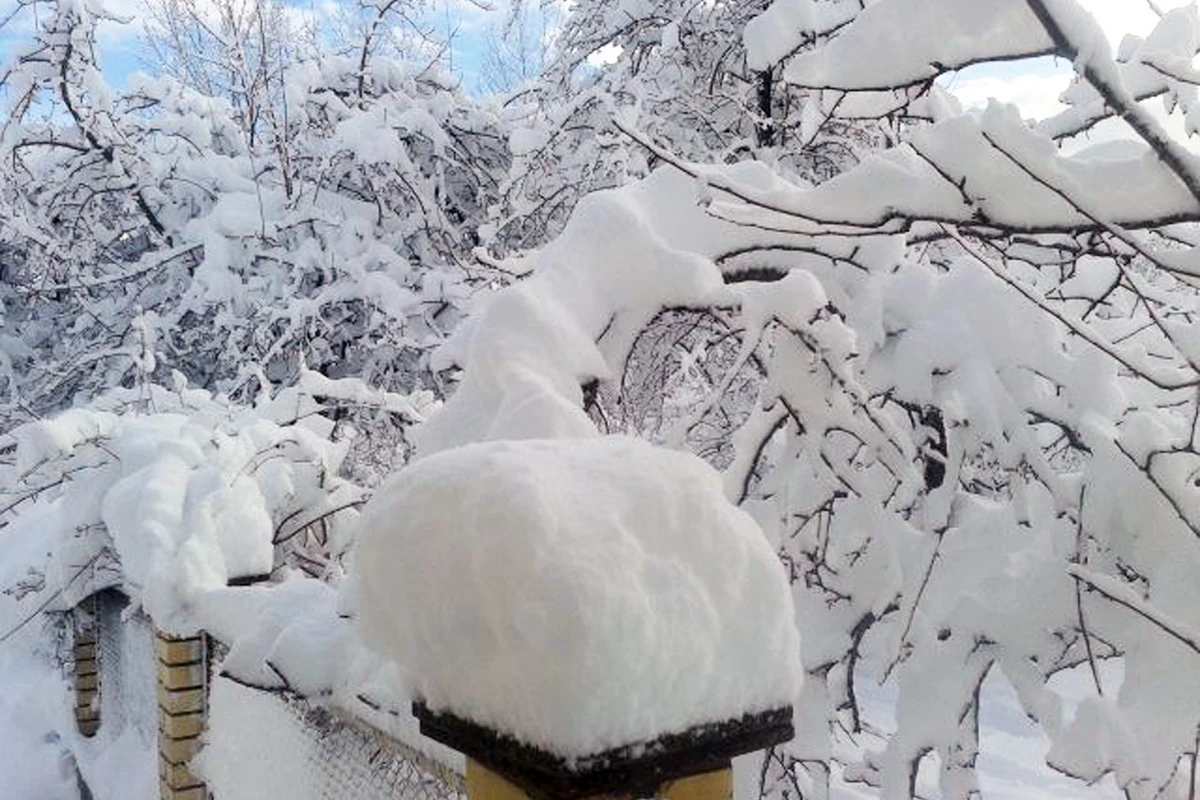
[418,0,1200,800]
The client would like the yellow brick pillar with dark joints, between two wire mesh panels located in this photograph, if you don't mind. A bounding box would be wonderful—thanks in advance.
[155,631,209,800]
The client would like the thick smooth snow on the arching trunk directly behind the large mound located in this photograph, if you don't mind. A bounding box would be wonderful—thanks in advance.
[414,166,739,455]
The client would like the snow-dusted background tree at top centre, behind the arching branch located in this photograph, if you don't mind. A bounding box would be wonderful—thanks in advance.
[488,0,899,253]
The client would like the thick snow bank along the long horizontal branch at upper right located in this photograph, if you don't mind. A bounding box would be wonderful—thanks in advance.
[710,102,1194,236]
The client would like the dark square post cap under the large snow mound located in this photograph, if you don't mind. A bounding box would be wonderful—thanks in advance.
[413,702,794,800]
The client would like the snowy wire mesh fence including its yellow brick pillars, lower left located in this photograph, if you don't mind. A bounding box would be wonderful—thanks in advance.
[73,582,466,800]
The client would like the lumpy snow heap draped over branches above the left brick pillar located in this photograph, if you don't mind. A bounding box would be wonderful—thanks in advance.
[3,377,369,633]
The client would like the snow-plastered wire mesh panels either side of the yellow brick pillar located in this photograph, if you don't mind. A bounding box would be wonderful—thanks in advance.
[86,591,466,800]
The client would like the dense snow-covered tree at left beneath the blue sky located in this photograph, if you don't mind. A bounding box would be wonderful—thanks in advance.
[0,0,508,479]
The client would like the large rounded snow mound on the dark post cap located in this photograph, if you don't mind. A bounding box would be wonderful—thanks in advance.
[358,437,800,758]
